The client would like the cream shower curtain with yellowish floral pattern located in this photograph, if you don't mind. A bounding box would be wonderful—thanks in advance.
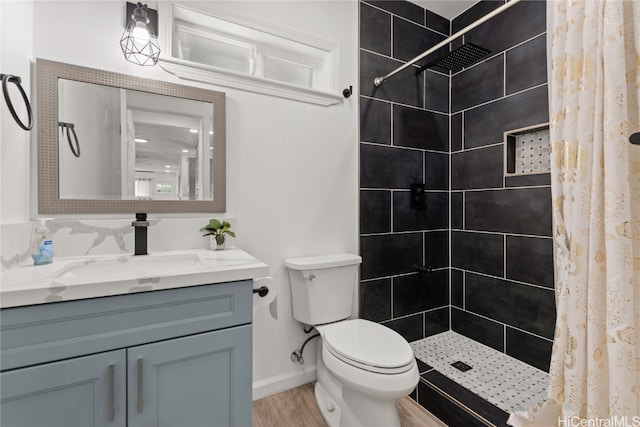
[509,0,640,426]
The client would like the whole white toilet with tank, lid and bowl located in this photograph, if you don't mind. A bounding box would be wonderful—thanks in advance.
[284,254,419,427]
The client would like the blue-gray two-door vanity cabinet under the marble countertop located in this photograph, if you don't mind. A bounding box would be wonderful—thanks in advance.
[0,281,252,427]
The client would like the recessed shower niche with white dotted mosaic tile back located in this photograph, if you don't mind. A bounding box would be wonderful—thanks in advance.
[504,123,551,176]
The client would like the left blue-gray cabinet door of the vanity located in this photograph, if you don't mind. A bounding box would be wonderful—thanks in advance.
[0,350,126,427]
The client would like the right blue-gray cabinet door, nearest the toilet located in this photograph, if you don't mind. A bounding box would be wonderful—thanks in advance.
[127,325,252,427]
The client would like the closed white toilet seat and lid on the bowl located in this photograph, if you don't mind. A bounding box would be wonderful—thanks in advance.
[316,319,415,375]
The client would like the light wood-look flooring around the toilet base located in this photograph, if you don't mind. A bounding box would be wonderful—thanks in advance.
[253,383,446,427]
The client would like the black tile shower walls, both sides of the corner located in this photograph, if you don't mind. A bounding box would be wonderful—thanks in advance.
[360,0,555,374]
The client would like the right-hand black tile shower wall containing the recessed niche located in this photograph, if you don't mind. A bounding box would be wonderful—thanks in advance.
[450,0,555,369]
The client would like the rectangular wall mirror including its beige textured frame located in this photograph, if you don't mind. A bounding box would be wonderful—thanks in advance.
[36,59,226,215]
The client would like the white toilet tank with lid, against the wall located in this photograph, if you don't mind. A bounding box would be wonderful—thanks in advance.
[284,253,362,325]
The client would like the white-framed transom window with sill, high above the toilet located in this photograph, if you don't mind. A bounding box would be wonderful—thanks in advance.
[158,2,343,106]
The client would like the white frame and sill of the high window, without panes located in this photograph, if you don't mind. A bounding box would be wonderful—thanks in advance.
[158,2,343,106]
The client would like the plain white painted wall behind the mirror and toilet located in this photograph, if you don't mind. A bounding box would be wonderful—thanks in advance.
[0,0,358,398]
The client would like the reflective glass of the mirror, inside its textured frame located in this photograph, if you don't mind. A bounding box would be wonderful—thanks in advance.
[58,79,215,200]
